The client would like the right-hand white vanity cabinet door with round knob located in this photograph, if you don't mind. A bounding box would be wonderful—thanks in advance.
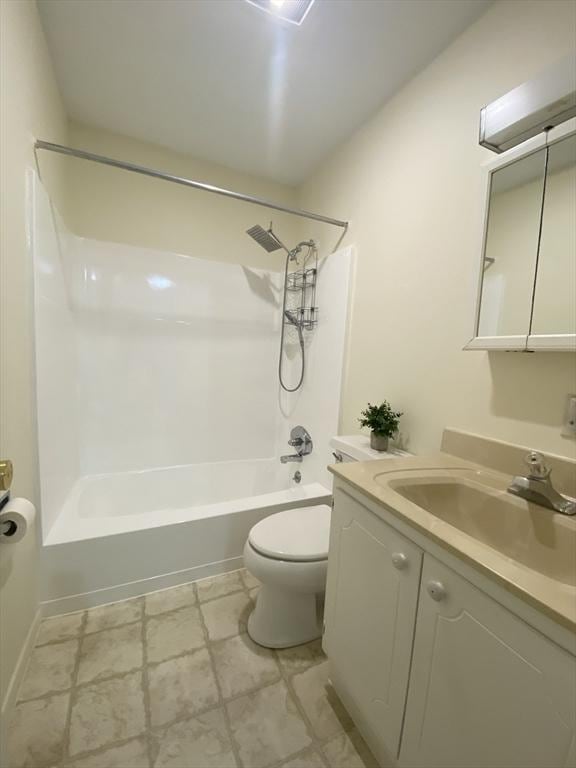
[400,555,576,768]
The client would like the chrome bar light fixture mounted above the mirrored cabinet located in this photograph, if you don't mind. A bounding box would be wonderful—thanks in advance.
[480,55,576,153]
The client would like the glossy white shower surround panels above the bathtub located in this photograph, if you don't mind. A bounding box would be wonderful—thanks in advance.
[32,171,351,537]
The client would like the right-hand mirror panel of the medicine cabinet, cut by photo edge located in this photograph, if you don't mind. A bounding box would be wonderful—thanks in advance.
[530,135,576,334]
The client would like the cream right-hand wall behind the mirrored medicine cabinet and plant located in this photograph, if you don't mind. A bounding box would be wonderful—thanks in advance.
[301,0,576,455]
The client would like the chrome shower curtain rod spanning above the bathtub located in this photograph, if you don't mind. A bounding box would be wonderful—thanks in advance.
[34,139,348,230]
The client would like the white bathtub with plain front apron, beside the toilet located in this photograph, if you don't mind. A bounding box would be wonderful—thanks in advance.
[42,459,331,615]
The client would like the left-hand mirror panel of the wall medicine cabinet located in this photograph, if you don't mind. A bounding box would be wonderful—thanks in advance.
[477,148,546,337]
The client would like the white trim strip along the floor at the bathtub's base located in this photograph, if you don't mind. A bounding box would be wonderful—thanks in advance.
[40,557,244,616]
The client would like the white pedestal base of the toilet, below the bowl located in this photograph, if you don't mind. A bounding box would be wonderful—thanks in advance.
[248,584,322,648]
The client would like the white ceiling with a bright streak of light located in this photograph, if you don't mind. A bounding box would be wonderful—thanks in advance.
[38,0,490,184]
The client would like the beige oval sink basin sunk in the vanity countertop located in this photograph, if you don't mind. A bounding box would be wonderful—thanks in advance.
[387,476,576,586]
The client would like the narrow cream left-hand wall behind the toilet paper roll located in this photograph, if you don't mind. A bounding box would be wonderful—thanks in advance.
[0,0,66,716]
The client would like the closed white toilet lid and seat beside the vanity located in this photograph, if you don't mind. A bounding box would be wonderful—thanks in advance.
[248,504,331,563]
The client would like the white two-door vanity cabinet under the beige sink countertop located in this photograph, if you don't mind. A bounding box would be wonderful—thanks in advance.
[324,484,576,768]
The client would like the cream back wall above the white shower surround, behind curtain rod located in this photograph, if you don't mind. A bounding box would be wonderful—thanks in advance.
[65,124,300,268]
